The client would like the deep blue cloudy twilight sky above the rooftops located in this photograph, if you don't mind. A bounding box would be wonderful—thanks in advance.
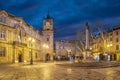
[0,0,120,39]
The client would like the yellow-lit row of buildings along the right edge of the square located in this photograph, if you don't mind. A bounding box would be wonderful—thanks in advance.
[90,26,120,61]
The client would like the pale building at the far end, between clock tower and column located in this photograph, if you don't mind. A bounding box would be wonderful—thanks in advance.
[56,40,80,60]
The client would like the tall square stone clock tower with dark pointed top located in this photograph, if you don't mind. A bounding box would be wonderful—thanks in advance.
[42,15,54,61]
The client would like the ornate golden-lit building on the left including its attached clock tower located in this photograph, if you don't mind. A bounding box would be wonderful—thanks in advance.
[0,11,54,63]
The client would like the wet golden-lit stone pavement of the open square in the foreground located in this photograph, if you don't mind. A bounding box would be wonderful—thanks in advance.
[0,63,120,80]
